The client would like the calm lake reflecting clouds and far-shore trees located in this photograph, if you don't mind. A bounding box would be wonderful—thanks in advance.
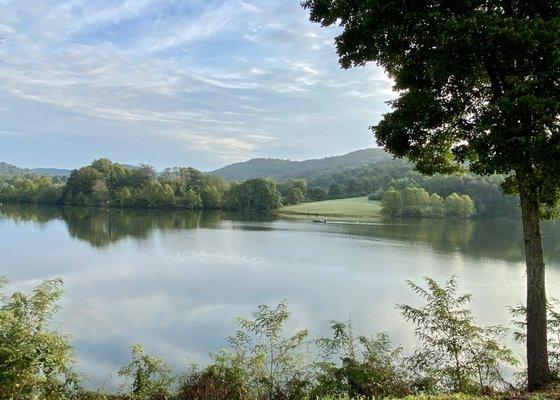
[0,205,560,385]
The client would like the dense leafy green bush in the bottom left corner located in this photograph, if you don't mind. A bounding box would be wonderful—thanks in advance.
[0,279,77,400]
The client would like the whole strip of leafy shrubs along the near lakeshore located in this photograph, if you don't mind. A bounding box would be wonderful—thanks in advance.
[0,277,560,400]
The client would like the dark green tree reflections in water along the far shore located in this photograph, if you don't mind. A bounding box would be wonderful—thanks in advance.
[0,206,560,263]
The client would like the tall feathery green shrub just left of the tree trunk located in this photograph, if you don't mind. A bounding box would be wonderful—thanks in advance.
[398,277,517,393]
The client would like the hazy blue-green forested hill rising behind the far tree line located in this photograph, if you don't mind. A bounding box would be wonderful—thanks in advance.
[210,149,392,181]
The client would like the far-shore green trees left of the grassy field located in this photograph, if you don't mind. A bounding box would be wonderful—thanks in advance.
[0,158,284,210]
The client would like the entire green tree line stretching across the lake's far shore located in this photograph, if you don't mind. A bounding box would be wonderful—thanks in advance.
[0,159,519,218]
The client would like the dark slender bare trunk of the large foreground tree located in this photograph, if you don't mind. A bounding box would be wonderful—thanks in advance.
[518,180,550,390]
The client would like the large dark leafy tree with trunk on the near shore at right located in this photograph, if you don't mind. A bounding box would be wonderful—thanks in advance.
[303,0,560,390]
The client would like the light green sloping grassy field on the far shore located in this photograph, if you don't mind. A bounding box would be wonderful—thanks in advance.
[278,197,381,221]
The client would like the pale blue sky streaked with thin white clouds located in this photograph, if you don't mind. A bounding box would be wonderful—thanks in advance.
[0,0,395,171]
